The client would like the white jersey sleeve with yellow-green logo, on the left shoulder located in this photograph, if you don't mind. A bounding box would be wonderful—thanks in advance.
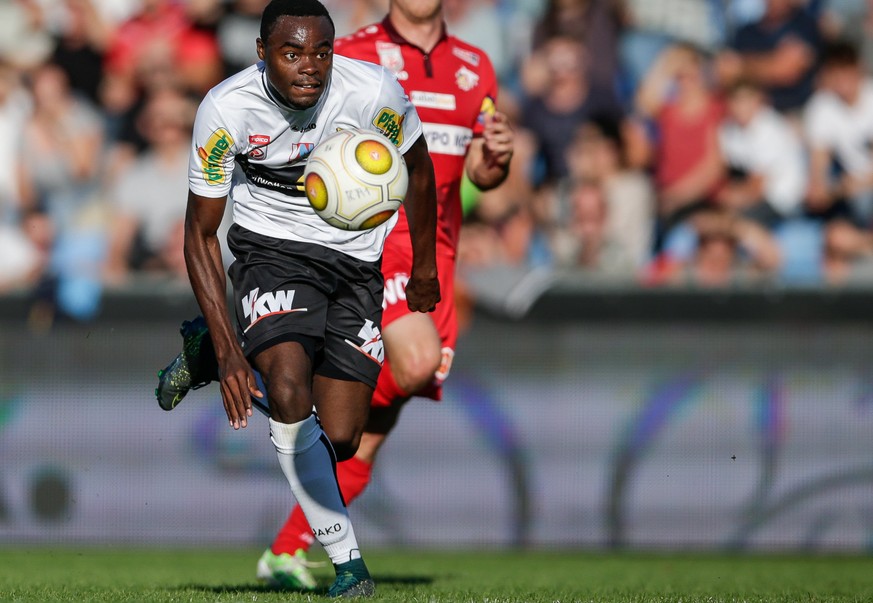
[188,93,238,198]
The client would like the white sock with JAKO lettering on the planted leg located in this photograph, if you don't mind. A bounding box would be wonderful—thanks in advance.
[270,415,361,564]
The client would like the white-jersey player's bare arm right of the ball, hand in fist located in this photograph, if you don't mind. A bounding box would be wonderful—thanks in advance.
[403,136,440,312]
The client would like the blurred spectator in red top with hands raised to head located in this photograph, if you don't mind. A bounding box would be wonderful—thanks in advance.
[637,45,723,247]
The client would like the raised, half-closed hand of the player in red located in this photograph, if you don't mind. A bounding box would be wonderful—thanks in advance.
[464,111,515,191]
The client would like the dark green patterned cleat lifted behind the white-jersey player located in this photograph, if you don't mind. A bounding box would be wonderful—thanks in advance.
[155,316,218,410]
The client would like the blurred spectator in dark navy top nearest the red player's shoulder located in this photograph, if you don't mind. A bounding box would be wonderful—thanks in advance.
[521,37,622,182]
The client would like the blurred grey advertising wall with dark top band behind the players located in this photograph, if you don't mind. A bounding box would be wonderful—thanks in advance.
[0,292,873,552]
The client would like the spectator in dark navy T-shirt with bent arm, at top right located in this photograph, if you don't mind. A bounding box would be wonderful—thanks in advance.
[717,0,821,112]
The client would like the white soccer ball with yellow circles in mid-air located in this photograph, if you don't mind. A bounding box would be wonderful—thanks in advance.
[303,129,409,230]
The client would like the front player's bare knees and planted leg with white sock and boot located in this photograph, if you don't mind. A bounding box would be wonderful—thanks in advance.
[253,342,374,596]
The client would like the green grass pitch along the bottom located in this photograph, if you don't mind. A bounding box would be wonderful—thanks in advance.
[0,548,873,603]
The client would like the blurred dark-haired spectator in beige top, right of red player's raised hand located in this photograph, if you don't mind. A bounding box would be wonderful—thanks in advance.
[568,118,655,272]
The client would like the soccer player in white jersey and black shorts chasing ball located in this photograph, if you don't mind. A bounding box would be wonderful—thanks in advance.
[185,0,440,597]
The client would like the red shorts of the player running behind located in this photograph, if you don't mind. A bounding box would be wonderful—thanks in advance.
[382,236,458,400]
